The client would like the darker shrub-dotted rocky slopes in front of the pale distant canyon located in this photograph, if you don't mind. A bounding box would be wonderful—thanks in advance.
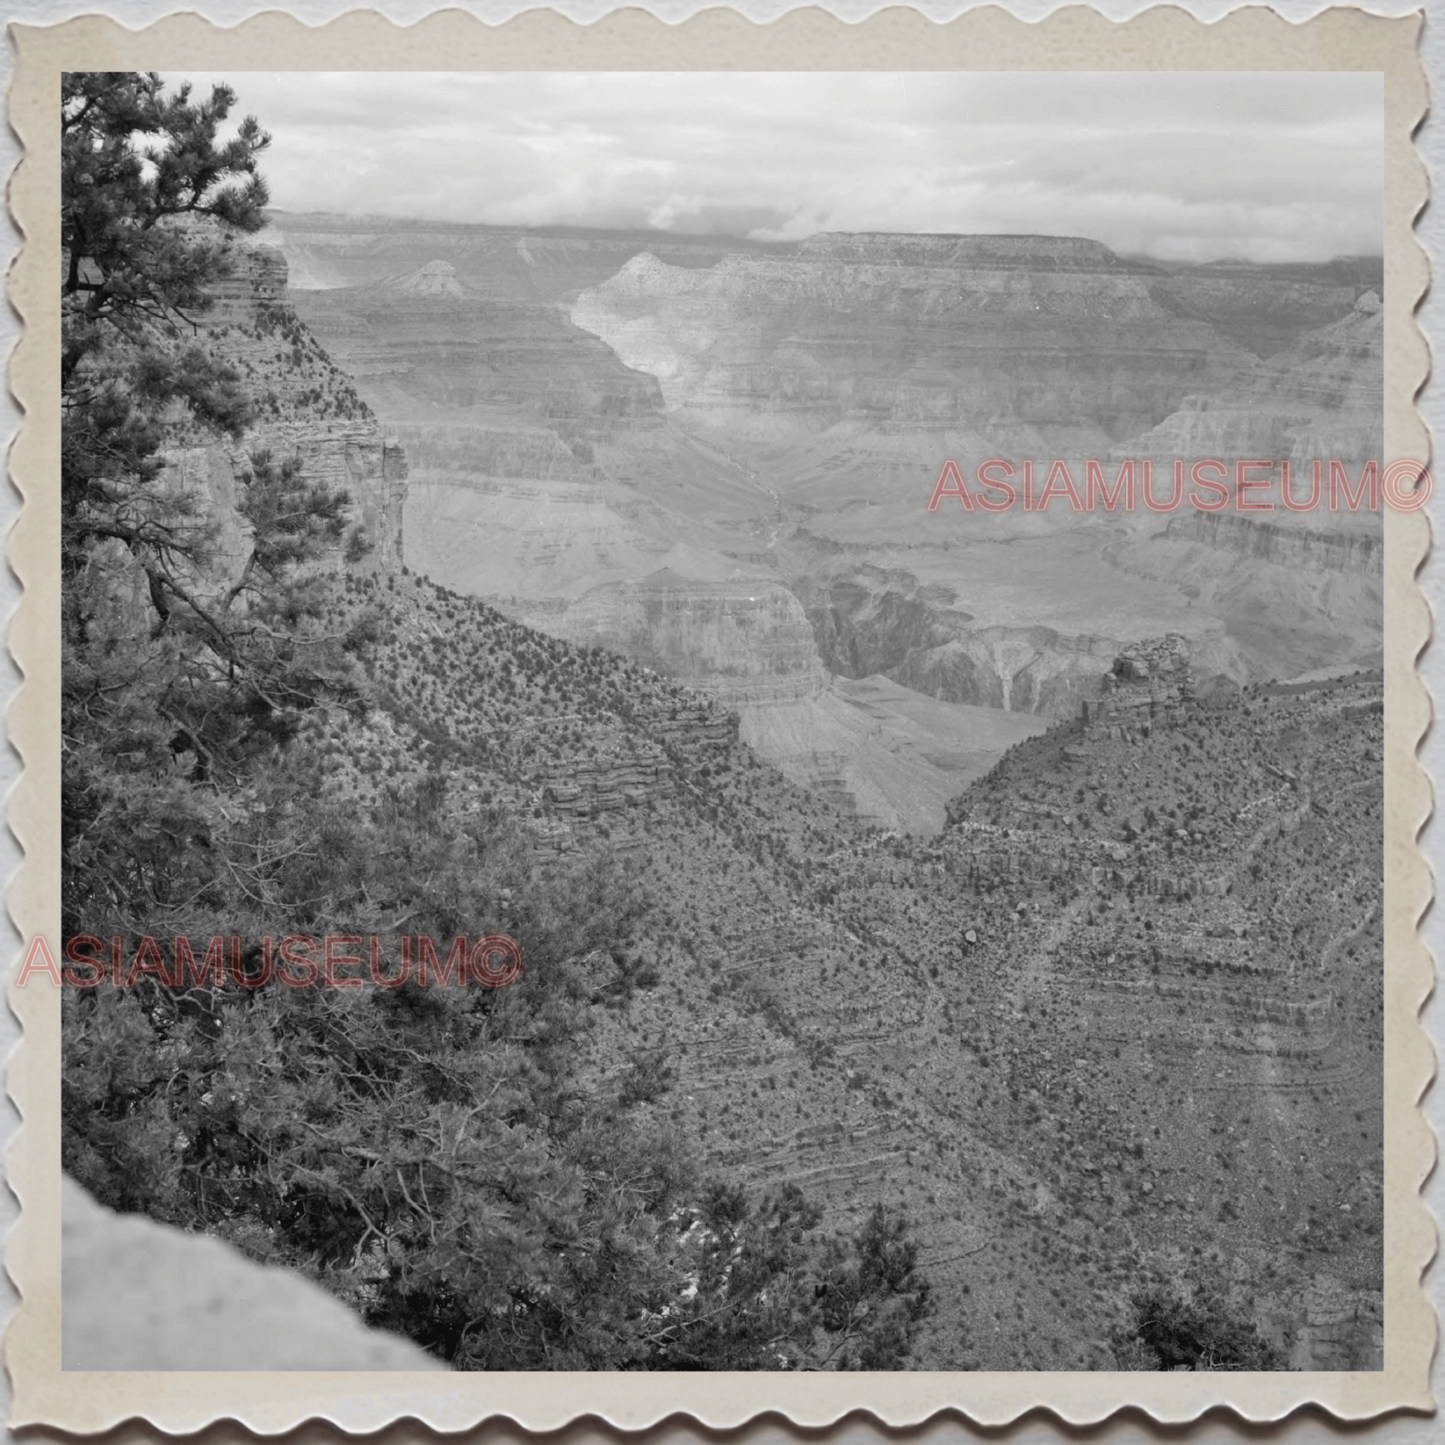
[284,560,1383,1368]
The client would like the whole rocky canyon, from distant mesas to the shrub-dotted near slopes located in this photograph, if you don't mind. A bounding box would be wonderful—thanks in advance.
[66,209,1384,1370]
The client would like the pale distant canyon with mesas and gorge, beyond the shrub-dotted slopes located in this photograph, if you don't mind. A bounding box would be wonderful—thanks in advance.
[275,214,1383,832]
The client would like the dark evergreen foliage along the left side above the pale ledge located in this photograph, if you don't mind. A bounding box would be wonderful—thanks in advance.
[62,74,928,1368]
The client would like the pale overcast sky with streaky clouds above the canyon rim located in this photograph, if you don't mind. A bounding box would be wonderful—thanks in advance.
[166,72,1383,262]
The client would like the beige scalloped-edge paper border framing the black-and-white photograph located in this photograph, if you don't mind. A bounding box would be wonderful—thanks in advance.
[6,7,1436,1432]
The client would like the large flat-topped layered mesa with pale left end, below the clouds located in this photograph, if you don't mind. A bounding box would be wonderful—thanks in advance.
[571,236,1247,455]
